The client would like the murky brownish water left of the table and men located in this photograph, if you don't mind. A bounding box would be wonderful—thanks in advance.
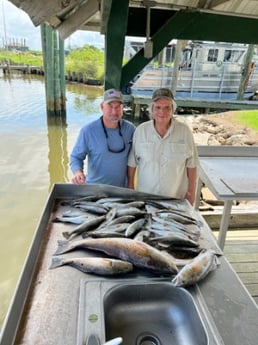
[0,71,103,329]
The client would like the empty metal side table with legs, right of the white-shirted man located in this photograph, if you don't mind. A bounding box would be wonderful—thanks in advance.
[195,146,258,250]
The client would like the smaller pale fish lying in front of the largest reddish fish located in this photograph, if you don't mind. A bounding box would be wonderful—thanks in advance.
[49,256,133,276]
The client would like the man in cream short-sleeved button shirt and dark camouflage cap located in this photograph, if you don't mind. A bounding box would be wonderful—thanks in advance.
[128,88,198,205]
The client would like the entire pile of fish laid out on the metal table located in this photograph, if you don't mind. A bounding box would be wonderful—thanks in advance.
[50,196,218,286]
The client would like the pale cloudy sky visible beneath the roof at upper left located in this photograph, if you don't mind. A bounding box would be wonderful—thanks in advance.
[0,0,104,50]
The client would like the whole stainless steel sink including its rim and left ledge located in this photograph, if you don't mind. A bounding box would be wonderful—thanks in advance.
[77,279,223,345]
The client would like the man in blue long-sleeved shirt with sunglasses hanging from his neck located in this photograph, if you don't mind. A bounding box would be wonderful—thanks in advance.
[70,89,135,187]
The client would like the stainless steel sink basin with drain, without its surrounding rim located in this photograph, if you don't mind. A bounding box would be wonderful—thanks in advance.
[103,282,208,345]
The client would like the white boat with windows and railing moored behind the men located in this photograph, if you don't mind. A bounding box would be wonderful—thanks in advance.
[131,41,258,99]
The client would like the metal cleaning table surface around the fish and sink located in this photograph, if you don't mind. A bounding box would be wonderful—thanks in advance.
[0,184,258,345]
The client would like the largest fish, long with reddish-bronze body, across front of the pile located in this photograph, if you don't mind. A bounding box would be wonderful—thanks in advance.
[54,238,178,274]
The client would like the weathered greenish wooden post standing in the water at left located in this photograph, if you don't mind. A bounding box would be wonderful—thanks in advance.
[41,23,66,116]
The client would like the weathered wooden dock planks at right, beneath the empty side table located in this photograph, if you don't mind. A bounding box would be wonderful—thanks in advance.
[213,228,258,304]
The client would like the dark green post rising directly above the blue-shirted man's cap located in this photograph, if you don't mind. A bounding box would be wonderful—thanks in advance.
[104,0,129,90]
